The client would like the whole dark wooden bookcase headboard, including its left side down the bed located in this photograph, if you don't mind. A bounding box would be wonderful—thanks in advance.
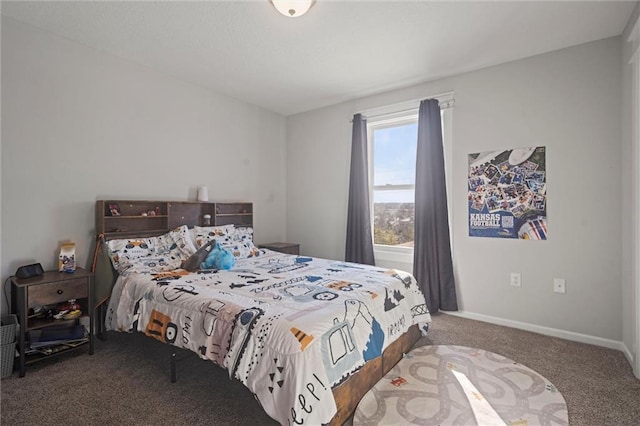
[91,200,253,307]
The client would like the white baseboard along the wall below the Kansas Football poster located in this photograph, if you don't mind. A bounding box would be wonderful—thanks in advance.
[440,311,633,356]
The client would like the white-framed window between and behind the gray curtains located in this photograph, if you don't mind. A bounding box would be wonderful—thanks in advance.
[367,101,452,261]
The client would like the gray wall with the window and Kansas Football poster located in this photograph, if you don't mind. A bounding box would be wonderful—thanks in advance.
[287,37,623,344]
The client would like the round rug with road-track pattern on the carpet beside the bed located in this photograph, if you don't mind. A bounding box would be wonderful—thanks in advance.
[353,346,569,426]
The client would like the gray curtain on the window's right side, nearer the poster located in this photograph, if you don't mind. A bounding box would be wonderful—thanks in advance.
[413,99,458,313]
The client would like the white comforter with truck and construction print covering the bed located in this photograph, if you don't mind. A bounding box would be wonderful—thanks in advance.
[106,250,431,424]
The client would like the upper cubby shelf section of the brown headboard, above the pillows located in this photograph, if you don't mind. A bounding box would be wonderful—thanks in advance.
[96,200,253,240]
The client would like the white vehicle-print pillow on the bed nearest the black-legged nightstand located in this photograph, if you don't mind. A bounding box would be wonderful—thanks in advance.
[107,226,196,274]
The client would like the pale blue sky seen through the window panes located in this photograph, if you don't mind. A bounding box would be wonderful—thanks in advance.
[373,123,418,203]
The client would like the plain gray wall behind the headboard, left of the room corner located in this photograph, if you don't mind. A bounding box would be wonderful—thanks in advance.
[1,16,286,312]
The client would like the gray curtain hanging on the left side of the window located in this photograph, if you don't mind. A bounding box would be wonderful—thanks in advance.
[344,114,375,265]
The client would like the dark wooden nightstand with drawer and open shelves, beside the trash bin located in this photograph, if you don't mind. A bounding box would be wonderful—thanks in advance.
[11,268,94,377]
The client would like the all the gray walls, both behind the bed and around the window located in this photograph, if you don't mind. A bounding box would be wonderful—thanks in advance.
[0,12,638,370]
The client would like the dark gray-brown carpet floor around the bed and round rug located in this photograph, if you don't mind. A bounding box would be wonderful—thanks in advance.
[0,314,640,426]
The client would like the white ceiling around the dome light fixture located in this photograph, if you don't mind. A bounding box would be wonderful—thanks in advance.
[1,0,636,115]
